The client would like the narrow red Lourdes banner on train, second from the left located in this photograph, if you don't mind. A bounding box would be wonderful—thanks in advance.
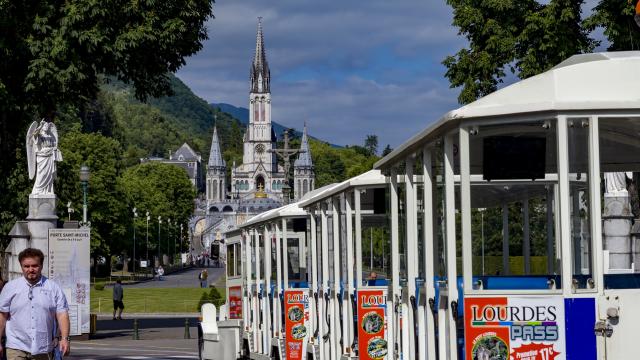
[284,289,309,360]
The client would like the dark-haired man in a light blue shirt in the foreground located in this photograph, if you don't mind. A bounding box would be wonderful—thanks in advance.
[0,248,70,360]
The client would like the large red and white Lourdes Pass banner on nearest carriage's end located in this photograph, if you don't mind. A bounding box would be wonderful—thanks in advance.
[464,297,566,360]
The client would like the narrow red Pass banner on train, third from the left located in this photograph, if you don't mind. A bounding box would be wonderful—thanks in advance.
[358,289,389,360]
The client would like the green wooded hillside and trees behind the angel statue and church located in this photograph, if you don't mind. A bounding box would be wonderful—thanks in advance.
[0,72,378,255]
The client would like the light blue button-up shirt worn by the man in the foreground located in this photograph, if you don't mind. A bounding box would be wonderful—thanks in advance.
[0,276,69,355]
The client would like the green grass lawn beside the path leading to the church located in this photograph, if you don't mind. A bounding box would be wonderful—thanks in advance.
[91,286,225,313]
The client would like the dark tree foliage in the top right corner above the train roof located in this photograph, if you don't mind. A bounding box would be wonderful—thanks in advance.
[584,0,640,51]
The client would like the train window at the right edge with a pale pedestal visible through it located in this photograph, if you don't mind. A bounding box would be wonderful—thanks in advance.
[598,117,640,289]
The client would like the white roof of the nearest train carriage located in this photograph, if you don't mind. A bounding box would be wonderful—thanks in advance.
[374,51,640,169]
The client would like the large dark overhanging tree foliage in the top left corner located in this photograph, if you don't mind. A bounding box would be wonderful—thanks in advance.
[0,0,212,211]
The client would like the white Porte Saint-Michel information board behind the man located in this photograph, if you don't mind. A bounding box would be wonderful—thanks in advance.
[48,228,91,335]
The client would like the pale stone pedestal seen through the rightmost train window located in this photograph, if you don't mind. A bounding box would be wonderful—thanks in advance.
[602,191,640,271]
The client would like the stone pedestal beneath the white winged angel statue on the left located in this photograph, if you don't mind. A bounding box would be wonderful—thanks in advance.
[27,194,58,274]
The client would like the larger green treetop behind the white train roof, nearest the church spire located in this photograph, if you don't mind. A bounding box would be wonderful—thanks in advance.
[443,0,596,104]
